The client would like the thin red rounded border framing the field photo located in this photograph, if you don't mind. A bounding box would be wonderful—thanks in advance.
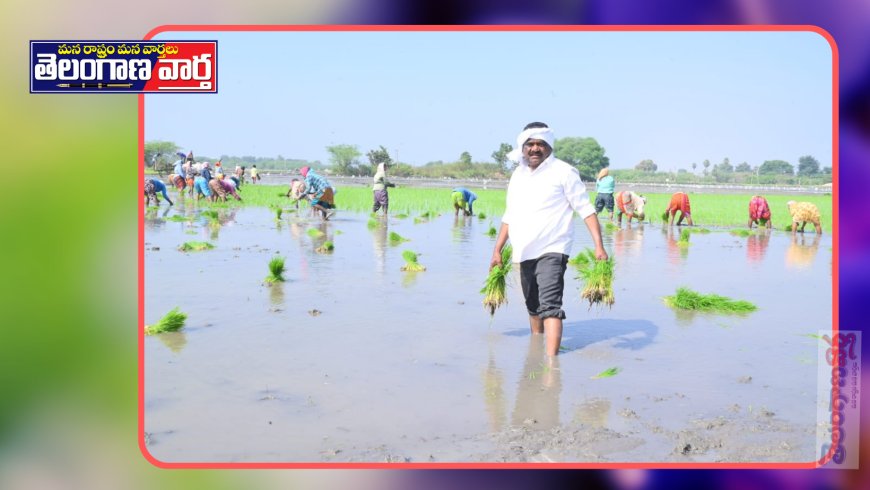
[138,24,840,470]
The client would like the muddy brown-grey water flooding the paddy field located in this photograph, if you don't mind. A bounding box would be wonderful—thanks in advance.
[144,209,832,462]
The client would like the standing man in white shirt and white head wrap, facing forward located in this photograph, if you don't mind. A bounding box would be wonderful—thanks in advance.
[490,123,607,356]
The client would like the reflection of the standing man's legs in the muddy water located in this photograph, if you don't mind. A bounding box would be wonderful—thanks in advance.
[511,335,562,430]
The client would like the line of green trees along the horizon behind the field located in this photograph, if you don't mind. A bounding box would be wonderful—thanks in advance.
[145,137,832,183]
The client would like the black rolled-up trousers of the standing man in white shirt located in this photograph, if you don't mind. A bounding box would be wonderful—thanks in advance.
[520,253,568,319]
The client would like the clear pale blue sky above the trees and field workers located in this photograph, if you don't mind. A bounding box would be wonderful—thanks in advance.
[145,32,832,171]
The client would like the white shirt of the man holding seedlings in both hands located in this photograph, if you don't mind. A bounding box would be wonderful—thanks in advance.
[501,154,595,262]
